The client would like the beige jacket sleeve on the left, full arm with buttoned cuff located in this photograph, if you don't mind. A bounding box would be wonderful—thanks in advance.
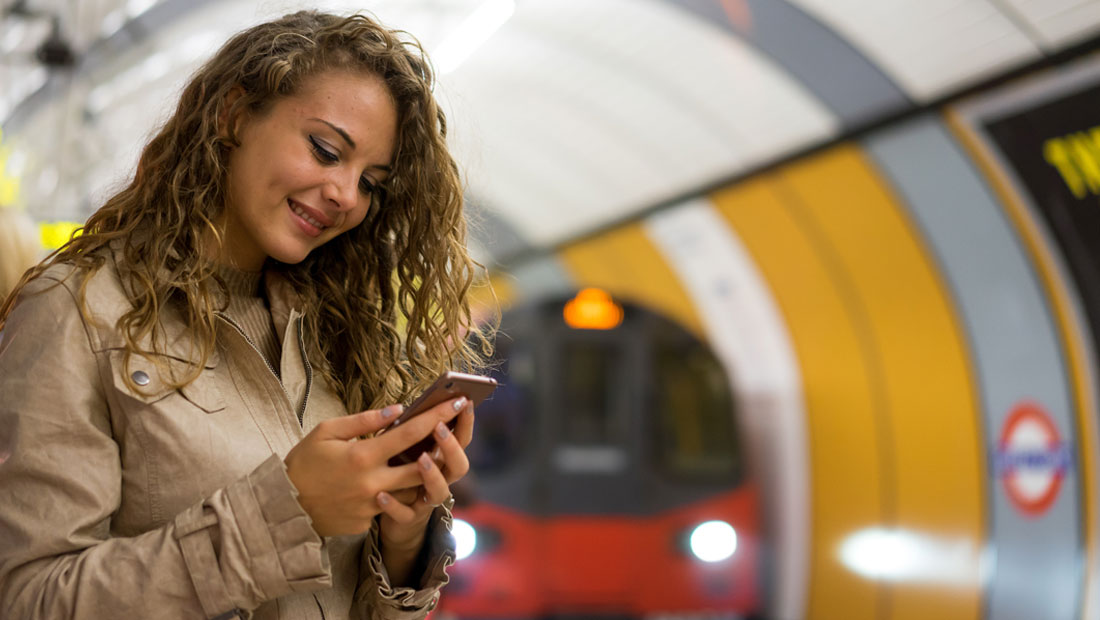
[0,278,331,619]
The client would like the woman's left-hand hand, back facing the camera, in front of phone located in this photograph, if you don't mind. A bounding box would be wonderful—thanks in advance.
[284,398,473,542]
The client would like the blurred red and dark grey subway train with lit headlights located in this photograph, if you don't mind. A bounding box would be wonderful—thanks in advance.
[439,289,761,618]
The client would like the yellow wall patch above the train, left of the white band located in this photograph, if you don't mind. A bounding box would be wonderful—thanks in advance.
[560,223,703,339]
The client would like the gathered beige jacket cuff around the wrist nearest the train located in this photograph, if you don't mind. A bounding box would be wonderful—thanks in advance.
[352,506,455,620]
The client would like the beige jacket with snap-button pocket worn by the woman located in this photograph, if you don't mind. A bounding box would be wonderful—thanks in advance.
[0,249,454,620]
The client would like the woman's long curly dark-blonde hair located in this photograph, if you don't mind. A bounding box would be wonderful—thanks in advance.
[0,11,490,411]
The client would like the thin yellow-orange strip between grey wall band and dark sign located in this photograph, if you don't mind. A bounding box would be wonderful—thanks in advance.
[945,110,1100,619]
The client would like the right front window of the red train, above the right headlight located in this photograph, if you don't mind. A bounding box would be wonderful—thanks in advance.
[653,340,740,476]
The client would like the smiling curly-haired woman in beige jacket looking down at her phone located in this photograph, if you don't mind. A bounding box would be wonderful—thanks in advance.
[0,12,486,619]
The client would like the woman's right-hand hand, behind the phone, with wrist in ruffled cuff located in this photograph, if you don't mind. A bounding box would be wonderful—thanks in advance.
[377,403,474,585]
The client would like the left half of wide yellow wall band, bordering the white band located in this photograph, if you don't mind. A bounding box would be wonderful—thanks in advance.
[711,177,882,620]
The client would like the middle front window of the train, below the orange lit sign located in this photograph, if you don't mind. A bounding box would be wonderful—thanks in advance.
[559,341,622,446]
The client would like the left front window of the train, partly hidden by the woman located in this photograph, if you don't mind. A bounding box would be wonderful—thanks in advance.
[466,339,535,473]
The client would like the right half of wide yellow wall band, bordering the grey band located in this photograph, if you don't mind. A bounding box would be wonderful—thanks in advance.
[780,145,986,620]
